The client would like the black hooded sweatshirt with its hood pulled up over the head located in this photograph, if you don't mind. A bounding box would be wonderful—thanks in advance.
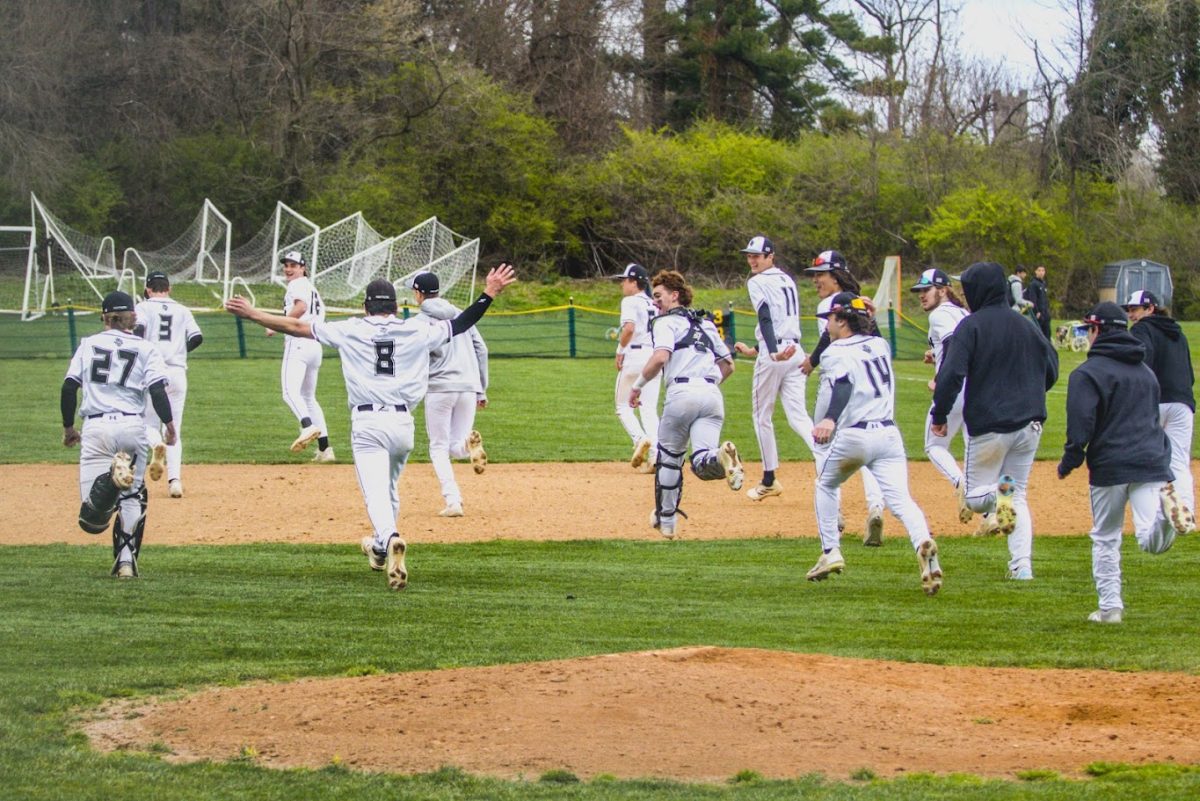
[929,261,1058,436]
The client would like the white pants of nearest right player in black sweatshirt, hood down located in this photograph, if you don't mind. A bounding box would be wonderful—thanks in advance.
[1091,481,1175,609]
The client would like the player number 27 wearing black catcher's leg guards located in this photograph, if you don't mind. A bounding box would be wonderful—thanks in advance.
[60,291,175,578]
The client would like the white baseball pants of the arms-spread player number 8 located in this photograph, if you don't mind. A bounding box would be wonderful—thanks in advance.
[350,406,415,550]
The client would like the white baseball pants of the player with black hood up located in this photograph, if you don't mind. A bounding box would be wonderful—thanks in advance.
[964,421,1042,571]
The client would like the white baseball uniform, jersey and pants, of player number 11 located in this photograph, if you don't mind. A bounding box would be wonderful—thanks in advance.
[746,267,814,470]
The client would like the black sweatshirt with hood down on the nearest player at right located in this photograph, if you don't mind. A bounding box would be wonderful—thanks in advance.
[1058,329,1171,487]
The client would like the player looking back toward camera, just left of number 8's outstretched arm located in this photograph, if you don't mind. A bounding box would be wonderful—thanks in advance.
[266,251,335,463]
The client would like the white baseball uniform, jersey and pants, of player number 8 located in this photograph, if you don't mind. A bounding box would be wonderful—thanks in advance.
[309,311,452,552]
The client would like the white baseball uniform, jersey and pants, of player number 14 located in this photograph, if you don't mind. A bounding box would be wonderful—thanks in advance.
[815,335,930,550]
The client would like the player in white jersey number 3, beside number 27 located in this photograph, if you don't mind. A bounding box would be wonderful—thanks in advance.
[133,272,204,498]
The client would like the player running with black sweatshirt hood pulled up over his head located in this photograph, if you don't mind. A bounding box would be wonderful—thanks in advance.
[929,261,1058,580]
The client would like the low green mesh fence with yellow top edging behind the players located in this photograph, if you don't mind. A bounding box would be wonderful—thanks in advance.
[0,306,928,360]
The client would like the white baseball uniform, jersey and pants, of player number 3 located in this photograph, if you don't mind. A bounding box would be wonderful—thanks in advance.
[134,296,200,481]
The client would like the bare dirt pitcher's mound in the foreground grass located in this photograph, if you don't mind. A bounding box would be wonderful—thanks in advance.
[88,648,1200,782]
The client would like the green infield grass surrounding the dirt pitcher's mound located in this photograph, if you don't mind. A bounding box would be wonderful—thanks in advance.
[7,537,1200,801]
